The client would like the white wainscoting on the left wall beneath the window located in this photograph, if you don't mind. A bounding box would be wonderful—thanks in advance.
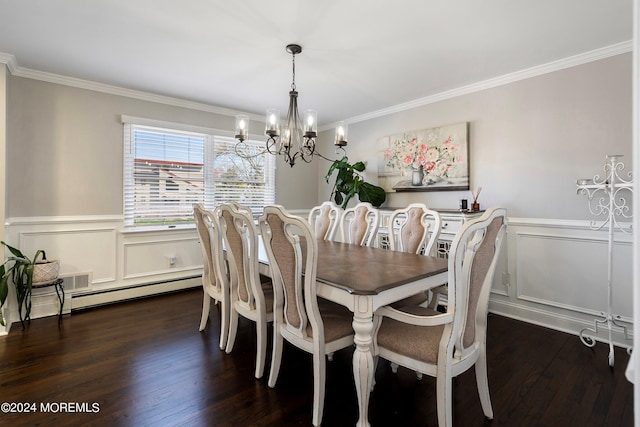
[5,216,202,330]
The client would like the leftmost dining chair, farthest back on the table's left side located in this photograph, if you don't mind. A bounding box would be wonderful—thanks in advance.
[193,203,229,349]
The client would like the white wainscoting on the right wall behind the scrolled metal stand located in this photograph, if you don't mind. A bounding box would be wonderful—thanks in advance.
[490,218,633,347]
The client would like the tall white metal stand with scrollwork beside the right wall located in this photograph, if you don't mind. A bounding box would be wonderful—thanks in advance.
[577,155,633,366]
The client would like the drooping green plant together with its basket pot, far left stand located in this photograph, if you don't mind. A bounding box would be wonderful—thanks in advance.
[0,242,60,327]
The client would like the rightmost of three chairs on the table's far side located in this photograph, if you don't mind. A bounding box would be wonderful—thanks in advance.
[389,203,446,308]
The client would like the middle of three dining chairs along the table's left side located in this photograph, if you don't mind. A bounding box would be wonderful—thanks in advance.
[219,204,273,378]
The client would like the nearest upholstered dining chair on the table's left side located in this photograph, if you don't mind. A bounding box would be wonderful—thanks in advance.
[259,206,354,426]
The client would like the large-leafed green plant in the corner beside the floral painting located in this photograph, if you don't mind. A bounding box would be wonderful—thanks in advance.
[325,156,387,209]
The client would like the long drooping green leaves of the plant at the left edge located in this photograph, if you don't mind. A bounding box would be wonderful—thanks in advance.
[0,242,57,327]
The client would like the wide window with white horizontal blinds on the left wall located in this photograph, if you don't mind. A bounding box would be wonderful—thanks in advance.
[124,122,275,227]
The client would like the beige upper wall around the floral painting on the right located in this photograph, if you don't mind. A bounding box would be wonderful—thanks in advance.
[318,53,633,219]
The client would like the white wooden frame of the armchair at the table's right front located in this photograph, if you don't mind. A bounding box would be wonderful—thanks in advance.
[374,208,507,427]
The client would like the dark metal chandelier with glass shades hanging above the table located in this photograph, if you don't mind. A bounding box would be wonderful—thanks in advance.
[235,44,347,167]
